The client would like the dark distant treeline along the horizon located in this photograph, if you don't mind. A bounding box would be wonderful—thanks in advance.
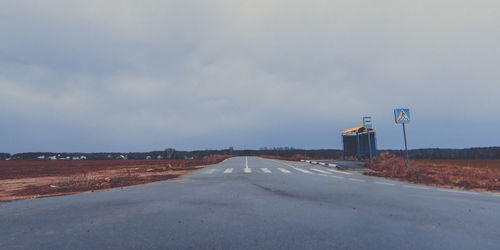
[0,147,500,160]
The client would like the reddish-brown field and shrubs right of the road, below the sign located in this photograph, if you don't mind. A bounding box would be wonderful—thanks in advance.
[367,153,500,192]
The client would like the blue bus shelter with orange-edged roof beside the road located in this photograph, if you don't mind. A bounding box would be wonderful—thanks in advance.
[342,126,377,159]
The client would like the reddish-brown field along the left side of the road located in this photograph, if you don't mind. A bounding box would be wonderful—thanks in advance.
[0,156,229,201]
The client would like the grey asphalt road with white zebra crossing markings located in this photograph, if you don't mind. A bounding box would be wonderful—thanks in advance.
[0,157,500,249]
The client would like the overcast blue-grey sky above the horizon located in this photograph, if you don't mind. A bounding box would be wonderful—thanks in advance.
[0,0,500,153]
